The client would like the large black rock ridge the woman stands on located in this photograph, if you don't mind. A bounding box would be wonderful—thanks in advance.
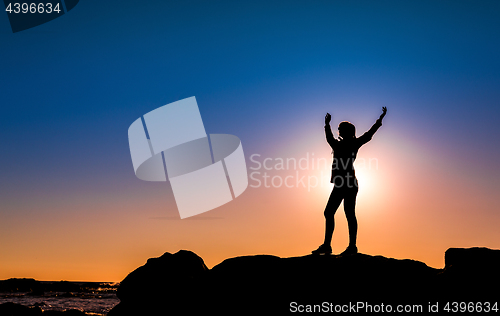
[108,248,500,316]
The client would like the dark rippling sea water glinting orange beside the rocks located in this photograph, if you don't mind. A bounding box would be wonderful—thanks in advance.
[0,282,120,316]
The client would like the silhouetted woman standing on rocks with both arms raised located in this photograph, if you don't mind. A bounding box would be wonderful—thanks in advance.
[312,107,387,255]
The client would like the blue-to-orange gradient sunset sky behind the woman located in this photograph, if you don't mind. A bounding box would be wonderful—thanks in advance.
[0,0,500,281]
